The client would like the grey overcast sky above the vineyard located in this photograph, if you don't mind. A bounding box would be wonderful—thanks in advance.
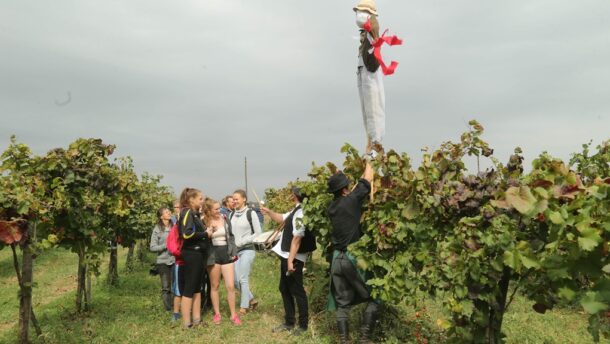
[0,0,610,198]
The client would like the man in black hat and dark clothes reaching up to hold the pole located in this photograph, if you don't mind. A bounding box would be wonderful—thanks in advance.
[327,156,380,343]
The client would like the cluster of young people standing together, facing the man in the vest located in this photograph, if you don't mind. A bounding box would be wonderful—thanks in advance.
[150,188,262,328]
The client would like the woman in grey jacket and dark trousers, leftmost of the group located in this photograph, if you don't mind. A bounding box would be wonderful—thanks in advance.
[150,208,175,311]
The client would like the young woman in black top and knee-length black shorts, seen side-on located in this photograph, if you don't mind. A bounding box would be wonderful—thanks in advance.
[178,188,209,328]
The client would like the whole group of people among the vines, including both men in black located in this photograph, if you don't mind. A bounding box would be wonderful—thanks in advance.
[150,155,380,343]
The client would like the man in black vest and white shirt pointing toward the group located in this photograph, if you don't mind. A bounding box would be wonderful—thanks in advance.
[261,187,316,335]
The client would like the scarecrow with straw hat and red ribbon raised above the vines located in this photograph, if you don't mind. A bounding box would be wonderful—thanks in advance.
[354,0,402,151]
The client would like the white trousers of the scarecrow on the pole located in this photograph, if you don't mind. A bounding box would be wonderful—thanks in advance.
[358,66,385,143]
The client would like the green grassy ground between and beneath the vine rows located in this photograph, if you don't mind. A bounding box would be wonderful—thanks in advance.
[0,249,604,343]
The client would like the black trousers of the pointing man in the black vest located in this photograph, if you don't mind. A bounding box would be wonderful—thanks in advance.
[279,258,309,329]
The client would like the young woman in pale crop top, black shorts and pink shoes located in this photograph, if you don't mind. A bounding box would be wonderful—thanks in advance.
[203,198,241,325]
